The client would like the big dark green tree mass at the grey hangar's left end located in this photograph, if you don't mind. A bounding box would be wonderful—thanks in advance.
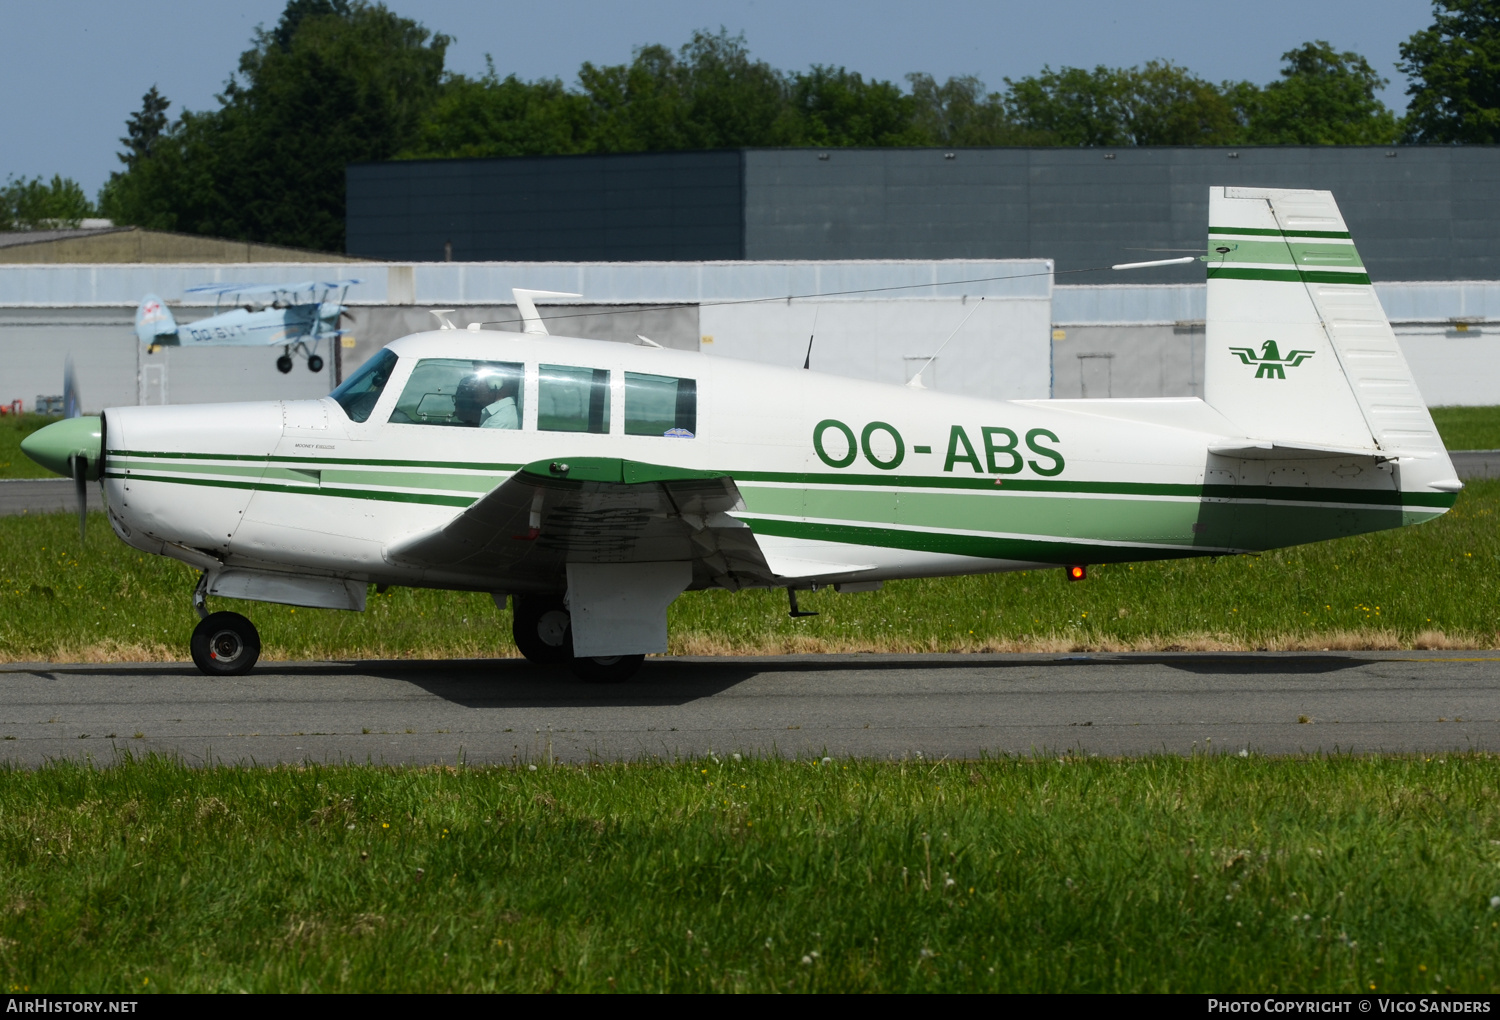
[101,0,449,251]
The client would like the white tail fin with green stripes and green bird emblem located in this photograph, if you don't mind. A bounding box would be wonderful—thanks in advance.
[1203,188,1454,480]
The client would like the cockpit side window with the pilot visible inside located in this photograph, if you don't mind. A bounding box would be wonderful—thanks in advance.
[390,357,525,429]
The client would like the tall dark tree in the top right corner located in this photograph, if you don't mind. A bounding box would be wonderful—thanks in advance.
[1397,0,1500,144]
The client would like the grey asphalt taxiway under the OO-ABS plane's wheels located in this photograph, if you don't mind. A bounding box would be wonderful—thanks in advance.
[0,653,1500,765]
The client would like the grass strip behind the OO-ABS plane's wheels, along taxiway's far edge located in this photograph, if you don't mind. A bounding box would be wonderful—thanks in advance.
[0,480,1500,662]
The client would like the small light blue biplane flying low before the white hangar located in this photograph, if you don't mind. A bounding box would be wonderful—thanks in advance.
[135,279,360,372]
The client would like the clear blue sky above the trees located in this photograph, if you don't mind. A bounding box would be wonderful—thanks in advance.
[0,0,1433,194]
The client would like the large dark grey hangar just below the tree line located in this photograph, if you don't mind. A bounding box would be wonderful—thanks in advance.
[348,146,1500,284]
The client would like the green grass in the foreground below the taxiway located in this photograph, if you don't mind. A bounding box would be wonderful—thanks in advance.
[0,755,1500,993]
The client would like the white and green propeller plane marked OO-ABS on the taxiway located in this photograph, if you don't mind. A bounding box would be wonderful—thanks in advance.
[23,188,1463,680]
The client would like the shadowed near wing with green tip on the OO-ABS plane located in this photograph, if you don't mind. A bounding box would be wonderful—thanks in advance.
[386,458,785,591]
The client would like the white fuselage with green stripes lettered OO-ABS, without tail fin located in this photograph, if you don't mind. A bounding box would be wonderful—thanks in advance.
[105,330,1454,593]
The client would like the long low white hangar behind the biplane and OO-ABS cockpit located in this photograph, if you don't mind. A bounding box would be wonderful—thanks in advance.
[0,260,1052,411]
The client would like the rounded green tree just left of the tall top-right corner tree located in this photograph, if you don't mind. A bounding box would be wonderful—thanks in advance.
[1245,39,1400,146]
